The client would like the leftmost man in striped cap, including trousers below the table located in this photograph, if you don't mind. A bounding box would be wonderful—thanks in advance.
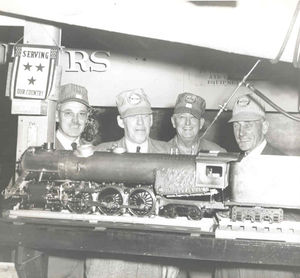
[47,84,90,278]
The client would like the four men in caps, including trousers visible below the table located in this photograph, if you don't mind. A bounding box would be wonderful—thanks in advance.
[49,84,281,278]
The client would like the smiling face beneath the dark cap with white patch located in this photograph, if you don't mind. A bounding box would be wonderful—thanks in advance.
[171,113,204,141]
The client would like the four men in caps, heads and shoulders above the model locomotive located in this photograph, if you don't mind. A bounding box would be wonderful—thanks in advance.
[56,84,281,155]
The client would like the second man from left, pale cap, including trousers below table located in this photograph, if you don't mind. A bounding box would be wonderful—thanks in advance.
[86,89,179,278]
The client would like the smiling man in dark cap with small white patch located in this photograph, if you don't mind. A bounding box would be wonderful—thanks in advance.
[169,93,226,154]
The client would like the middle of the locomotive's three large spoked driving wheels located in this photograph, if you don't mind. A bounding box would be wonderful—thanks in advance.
[98,187,124,215]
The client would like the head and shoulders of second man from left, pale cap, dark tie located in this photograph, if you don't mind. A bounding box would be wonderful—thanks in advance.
[96,89,169,153]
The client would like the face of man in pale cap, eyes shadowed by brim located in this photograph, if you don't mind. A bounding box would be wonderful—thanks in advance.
[118,115,153,144]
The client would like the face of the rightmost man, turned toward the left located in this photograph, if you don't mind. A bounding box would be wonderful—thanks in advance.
[233,120,268,152]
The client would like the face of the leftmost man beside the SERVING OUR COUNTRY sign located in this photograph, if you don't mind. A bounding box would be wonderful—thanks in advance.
[56,101,88,138]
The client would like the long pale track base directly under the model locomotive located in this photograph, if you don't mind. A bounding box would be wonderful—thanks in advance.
[3,210,215,235]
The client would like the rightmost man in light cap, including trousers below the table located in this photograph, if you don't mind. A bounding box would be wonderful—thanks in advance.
[214,94,290,278]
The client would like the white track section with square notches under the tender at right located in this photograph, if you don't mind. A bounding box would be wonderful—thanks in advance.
[215,218,300,243]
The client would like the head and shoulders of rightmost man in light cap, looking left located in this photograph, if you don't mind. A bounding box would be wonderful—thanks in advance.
[229,94,283,156]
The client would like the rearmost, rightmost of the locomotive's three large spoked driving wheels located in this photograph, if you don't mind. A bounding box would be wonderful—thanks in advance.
[128,188,155,216]
